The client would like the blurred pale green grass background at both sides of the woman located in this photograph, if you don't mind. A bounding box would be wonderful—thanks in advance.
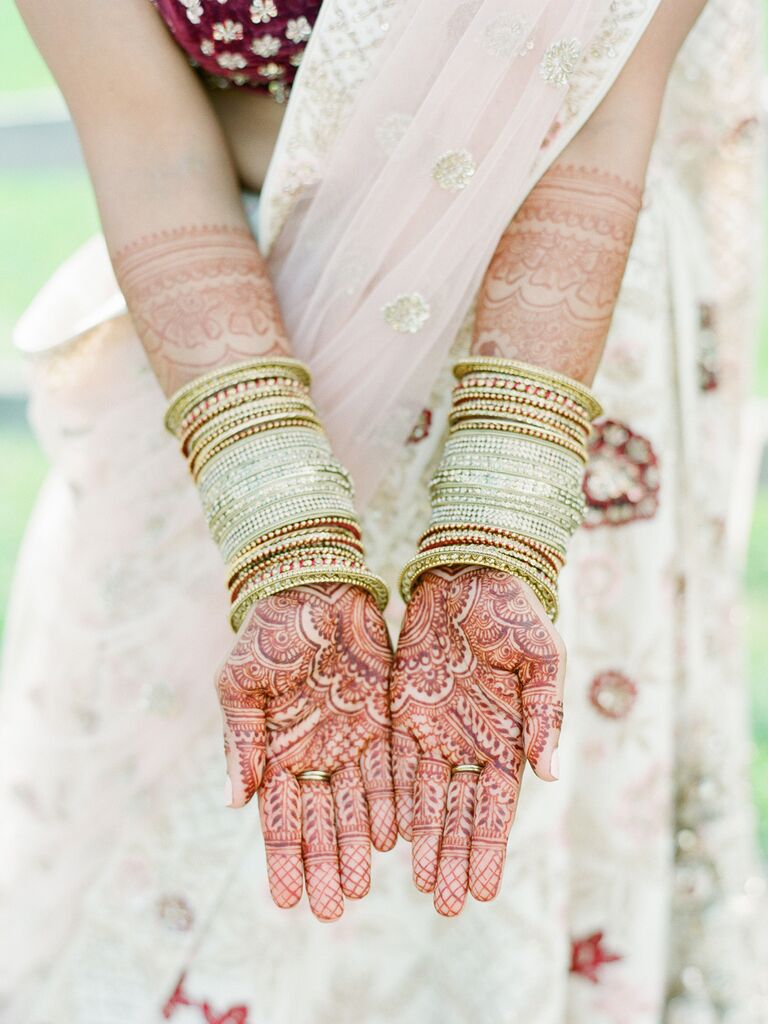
[0,0,768,854]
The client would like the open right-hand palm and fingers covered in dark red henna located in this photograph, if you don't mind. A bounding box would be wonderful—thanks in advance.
[391,566,565,915]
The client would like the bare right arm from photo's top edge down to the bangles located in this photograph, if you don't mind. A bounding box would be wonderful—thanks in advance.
[472,0,703,383]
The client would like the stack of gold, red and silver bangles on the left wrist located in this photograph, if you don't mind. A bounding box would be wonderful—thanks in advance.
[165,358,388,631]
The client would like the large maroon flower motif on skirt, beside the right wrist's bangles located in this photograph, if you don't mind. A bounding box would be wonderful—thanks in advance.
[584,420,658,528]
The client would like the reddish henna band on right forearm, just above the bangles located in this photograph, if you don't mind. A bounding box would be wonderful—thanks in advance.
[472,164,642,382]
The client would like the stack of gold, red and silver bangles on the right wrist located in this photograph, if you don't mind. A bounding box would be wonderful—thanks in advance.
[400,357,601,620]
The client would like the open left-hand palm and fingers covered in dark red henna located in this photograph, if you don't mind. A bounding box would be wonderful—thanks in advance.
[217,584,397,921]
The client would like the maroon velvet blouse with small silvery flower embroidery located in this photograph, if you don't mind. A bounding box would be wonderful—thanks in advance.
[152,0,322,102]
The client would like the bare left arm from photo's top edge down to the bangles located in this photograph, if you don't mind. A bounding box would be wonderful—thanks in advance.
[18,0,288,394]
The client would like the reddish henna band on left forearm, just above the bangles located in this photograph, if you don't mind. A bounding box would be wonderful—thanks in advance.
[113,225,289,393]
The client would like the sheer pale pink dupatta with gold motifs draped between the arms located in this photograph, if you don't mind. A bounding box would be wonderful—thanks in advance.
[261,0,618,505]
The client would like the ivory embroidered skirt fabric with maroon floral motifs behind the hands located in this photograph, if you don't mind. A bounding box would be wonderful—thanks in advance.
[0,0,768,1024]
